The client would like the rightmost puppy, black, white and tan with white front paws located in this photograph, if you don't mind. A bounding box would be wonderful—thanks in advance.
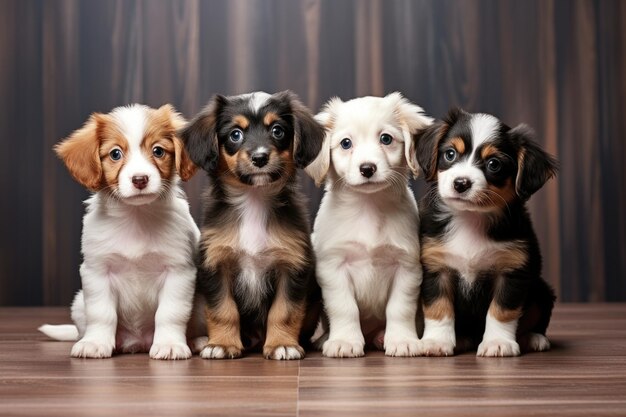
[417,109,557,356]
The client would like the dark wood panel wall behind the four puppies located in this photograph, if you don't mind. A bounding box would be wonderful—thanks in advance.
[0,0,626,305]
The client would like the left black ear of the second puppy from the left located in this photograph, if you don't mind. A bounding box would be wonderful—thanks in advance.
[178,94,228,173]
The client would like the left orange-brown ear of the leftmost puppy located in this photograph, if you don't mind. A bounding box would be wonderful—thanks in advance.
[53,113,107,191]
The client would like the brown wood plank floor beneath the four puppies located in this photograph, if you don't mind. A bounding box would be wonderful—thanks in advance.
[0,304,626,417]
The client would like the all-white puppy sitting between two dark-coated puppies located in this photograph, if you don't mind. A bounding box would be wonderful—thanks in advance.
[306,93,431,357]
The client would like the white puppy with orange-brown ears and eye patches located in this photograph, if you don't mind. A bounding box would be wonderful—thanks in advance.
[39,104,200,359]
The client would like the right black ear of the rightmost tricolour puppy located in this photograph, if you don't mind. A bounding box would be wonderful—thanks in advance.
[508,124,559,200]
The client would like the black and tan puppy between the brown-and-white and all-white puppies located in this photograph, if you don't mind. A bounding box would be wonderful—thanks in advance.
[181,91,324,359]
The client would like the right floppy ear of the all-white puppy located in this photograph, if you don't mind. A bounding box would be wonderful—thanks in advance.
[385,92,433,177]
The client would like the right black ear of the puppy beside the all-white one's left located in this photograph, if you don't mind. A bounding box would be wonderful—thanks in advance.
[277,90,324,168]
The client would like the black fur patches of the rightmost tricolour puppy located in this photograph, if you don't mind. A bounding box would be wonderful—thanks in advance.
[417,109,557,352]
